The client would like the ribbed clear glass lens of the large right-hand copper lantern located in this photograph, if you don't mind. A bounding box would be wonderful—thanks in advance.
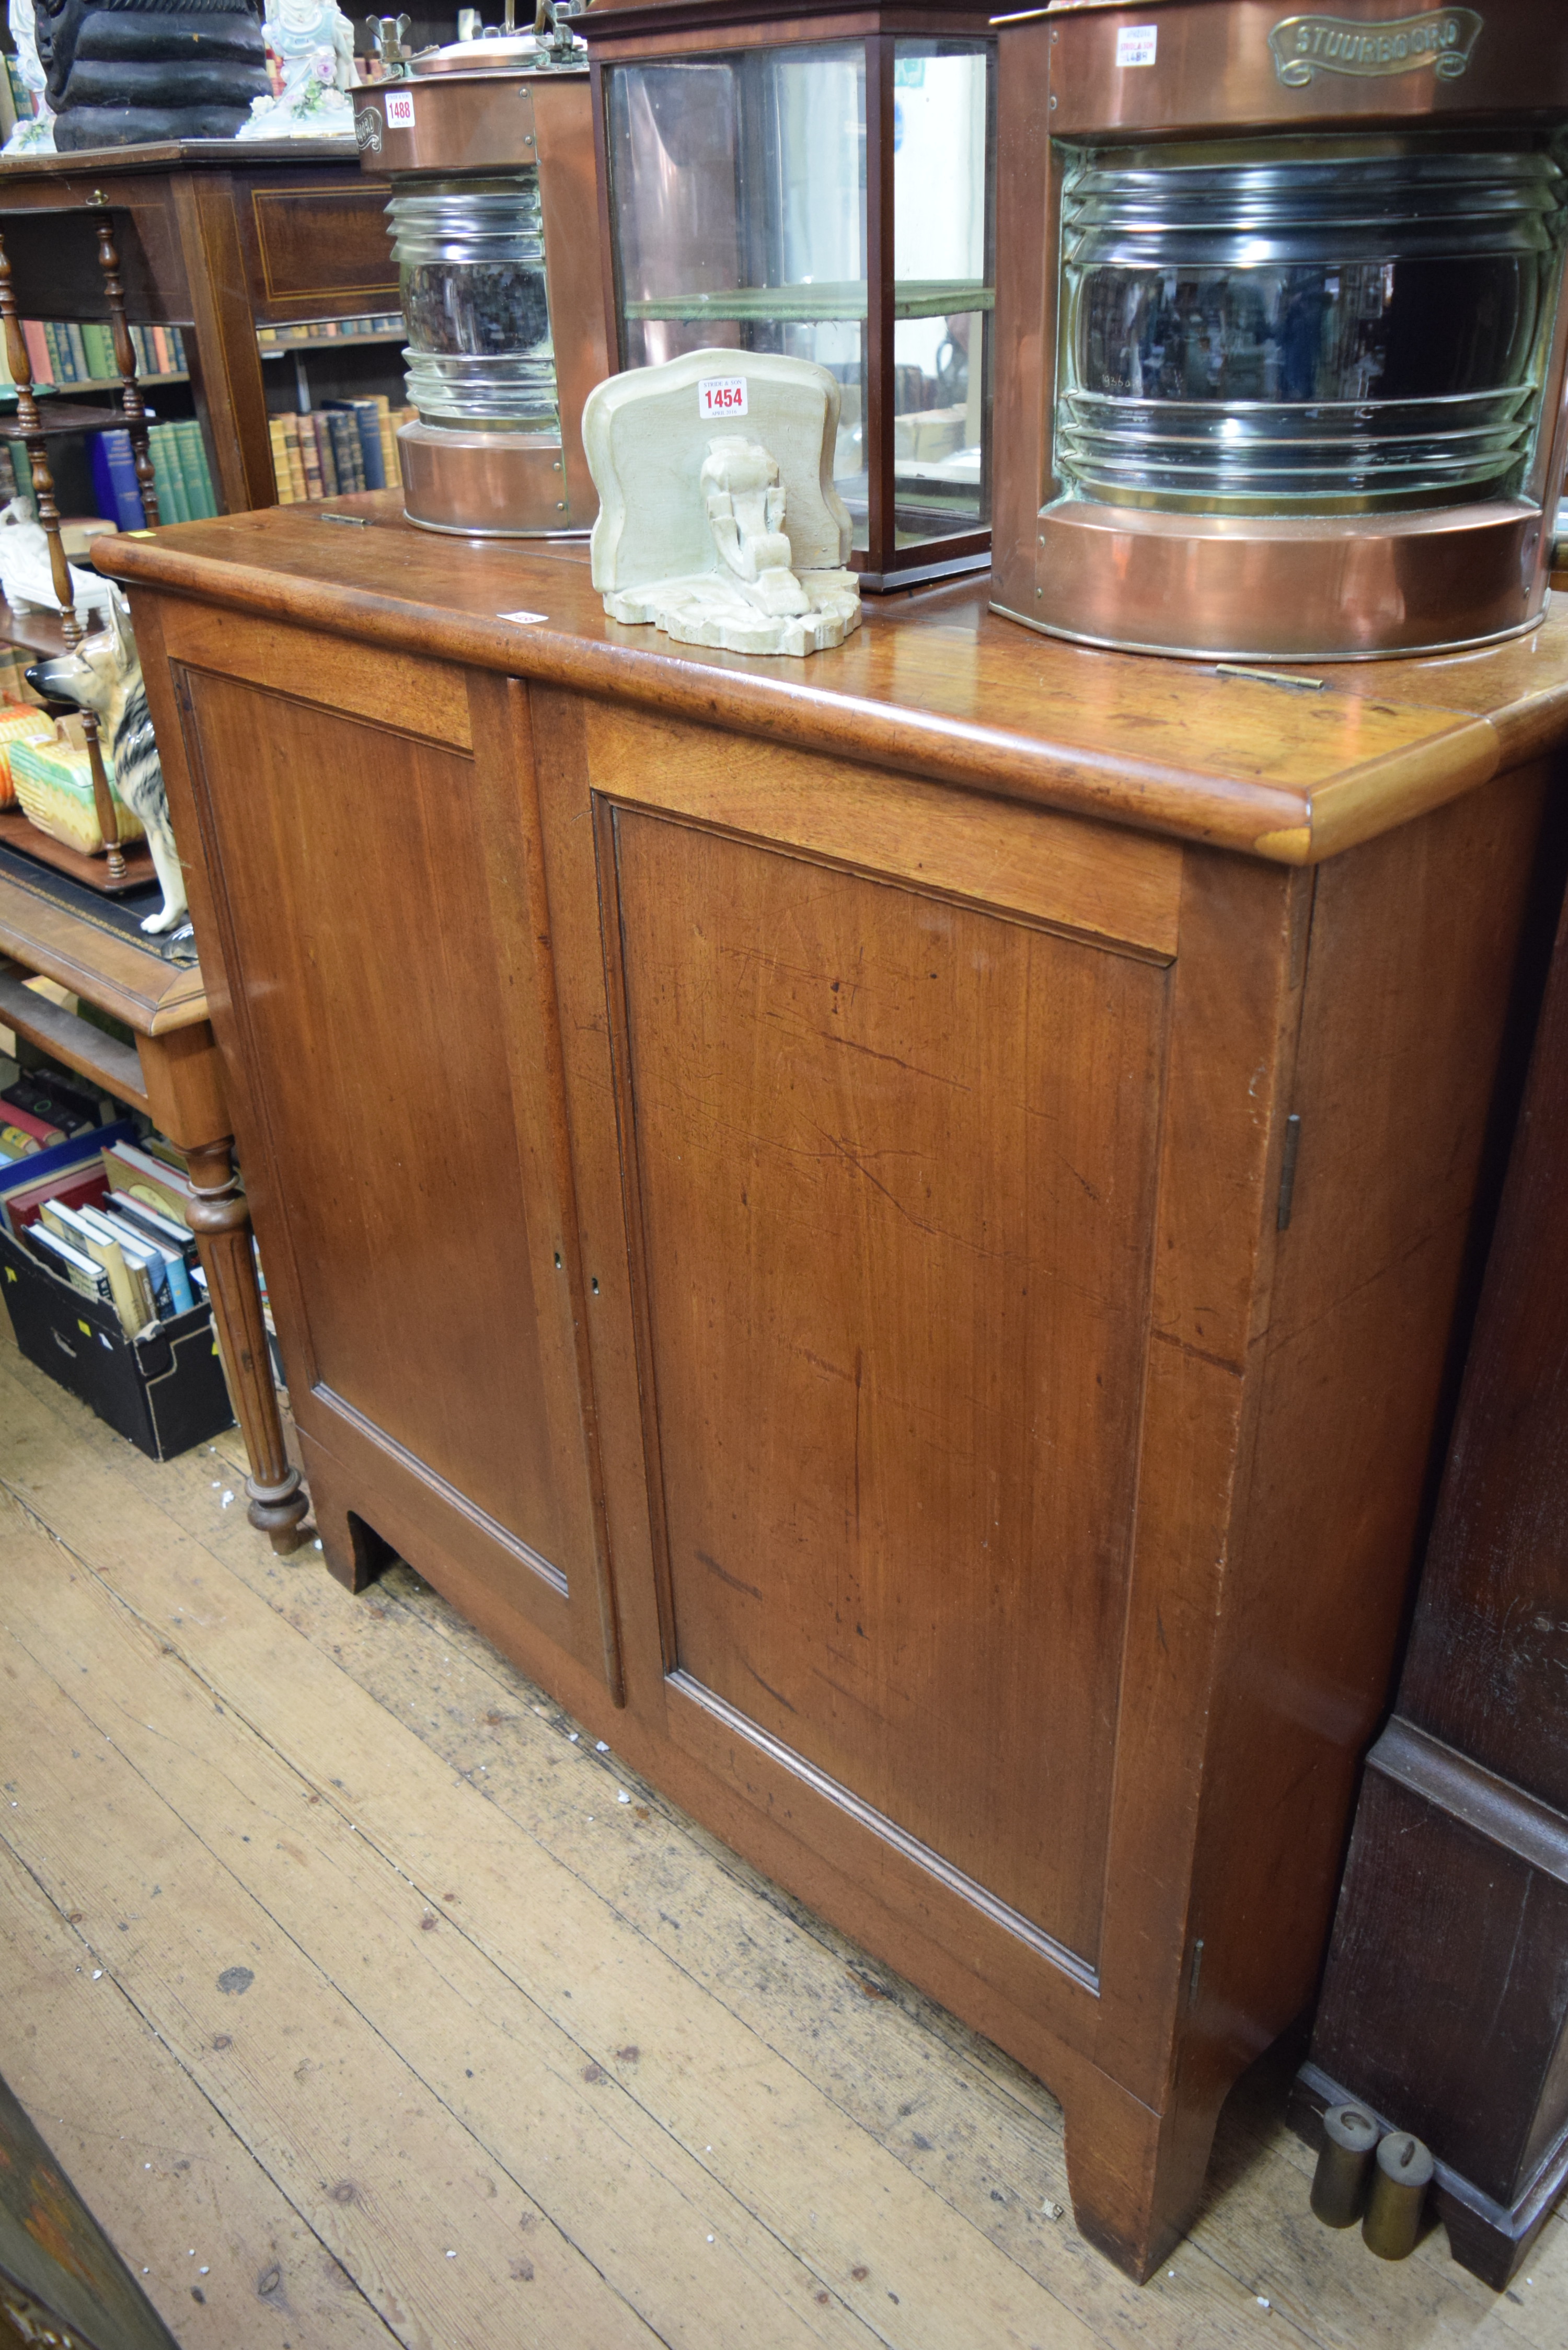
[1055,139,1566,515]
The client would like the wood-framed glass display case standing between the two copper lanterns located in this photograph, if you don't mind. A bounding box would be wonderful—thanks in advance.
[578,0,997,590]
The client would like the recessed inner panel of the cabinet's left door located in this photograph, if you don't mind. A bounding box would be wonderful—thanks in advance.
[175,674,592,1635]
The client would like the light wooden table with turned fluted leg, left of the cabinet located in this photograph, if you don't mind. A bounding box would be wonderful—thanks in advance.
[0,855,308,1551]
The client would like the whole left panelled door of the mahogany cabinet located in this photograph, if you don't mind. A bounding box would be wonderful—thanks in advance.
[171,634,620,1692]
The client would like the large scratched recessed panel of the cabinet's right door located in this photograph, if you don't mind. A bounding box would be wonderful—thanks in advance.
[614,813,1166,1962]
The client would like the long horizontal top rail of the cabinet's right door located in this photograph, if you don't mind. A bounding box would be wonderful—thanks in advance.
[585,702,1182,961]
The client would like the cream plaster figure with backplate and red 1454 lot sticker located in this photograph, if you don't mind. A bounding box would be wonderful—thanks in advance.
[583,350,860,655]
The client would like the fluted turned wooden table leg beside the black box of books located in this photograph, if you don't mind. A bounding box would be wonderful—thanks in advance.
[186,1140,310,1553]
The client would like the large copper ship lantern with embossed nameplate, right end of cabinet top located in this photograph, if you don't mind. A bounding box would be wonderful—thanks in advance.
[992,0,1568,660]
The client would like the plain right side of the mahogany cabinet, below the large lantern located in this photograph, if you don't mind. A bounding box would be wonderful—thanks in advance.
[1194,768,1544,2087]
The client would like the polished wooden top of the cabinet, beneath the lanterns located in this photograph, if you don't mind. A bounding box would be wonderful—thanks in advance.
[96,491,1568,865]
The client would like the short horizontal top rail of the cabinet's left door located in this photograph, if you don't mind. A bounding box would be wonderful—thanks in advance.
[162,602,472,750]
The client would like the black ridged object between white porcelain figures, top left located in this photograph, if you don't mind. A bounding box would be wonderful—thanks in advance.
[33,0,268,153]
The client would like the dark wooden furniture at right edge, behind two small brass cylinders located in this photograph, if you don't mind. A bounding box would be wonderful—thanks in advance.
[1298,874,1568,2287]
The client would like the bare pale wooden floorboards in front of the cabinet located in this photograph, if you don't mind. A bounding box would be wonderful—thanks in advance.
[0,1328,1568,2350]
